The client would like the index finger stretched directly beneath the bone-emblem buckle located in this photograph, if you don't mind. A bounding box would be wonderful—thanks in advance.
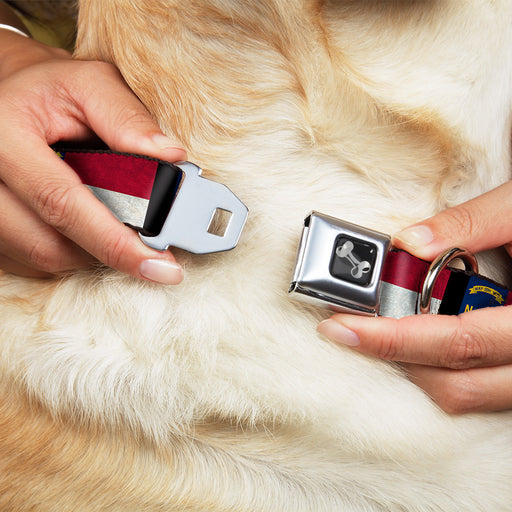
[318,306,512,369]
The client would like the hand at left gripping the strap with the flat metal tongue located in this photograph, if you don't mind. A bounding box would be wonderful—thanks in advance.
[0,30,186,284]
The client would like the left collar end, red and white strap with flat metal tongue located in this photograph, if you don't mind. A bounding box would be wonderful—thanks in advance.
[53,146,248,254]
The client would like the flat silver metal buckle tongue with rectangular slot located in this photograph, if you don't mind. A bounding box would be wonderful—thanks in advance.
[140,162,248,254]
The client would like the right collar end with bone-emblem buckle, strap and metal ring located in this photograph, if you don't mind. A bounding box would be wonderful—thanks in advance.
[289,212,512,318]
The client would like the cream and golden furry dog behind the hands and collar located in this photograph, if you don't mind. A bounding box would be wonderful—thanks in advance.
[0,0,512,512]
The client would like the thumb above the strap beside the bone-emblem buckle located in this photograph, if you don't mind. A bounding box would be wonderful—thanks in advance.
[393,181,512,261]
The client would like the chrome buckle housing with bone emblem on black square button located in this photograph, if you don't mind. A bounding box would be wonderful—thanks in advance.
[288,212,391,316]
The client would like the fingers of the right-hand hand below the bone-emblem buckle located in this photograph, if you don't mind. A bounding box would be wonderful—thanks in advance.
[318,307,512,412]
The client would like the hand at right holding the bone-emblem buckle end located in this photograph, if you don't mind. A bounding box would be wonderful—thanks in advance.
[318,182,512,413]
